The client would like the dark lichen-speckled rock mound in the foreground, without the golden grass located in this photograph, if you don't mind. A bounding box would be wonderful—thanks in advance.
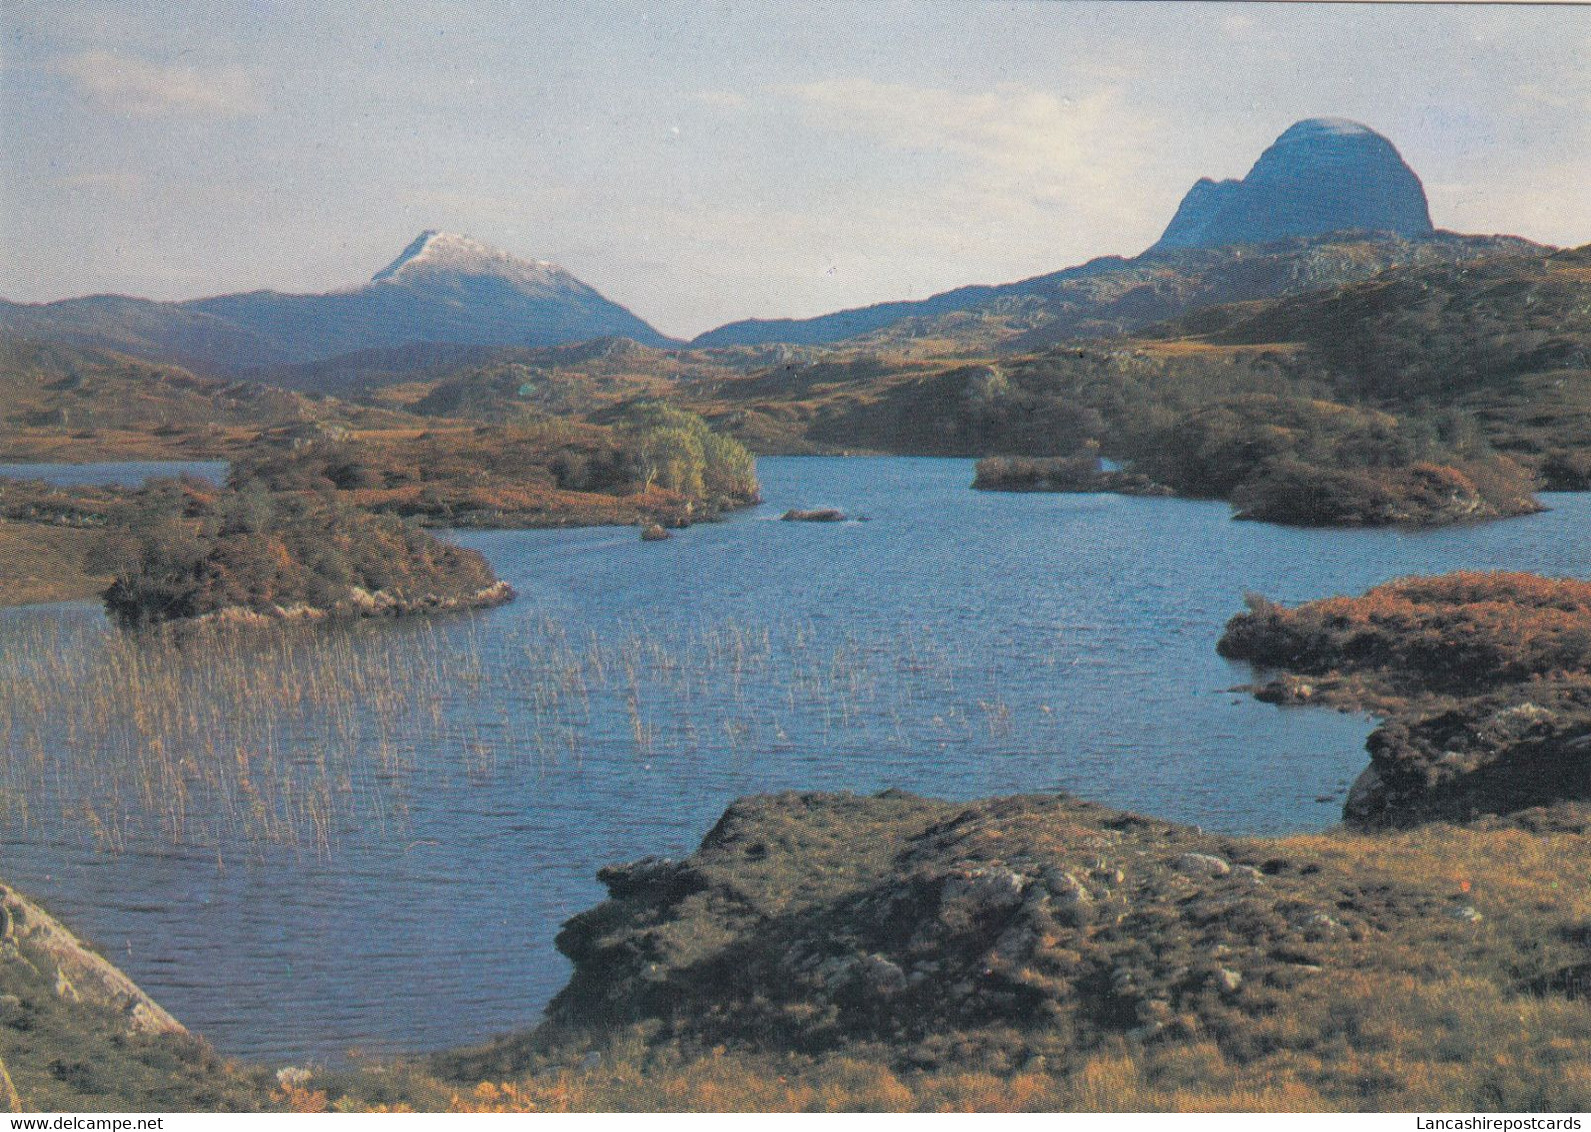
[450,792,1443,1076]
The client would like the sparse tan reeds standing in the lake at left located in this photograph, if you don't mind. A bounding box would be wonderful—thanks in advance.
[0,611,1012,857]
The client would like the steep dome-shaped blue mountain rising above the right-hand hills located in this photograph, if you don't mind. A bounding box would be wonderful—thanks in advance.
[1152,118,1433,251]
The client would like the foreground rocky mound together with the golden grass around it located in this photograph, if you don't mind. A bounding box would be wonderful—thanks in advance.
[436,792,1591,1111]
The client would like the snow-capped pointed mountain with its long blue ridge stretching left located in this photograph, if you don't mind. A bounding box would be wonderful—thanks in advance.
[0,231,671,374]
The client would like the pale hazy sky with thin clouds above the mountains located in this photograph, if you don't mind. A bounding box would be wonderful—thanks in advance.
[0,0,1591,337]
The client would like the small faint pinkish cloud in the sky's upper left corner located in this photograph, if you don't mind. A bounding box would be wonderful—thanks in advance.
[56,48,261,118]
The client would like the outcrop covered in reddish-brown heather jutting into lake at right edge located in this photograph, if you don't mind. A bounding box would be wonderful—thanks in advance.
[1219,574,1591,828]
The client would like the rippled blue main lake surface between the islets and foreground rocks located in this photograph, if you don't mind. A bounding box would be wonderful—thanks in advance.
[0,458,1591,1062]
